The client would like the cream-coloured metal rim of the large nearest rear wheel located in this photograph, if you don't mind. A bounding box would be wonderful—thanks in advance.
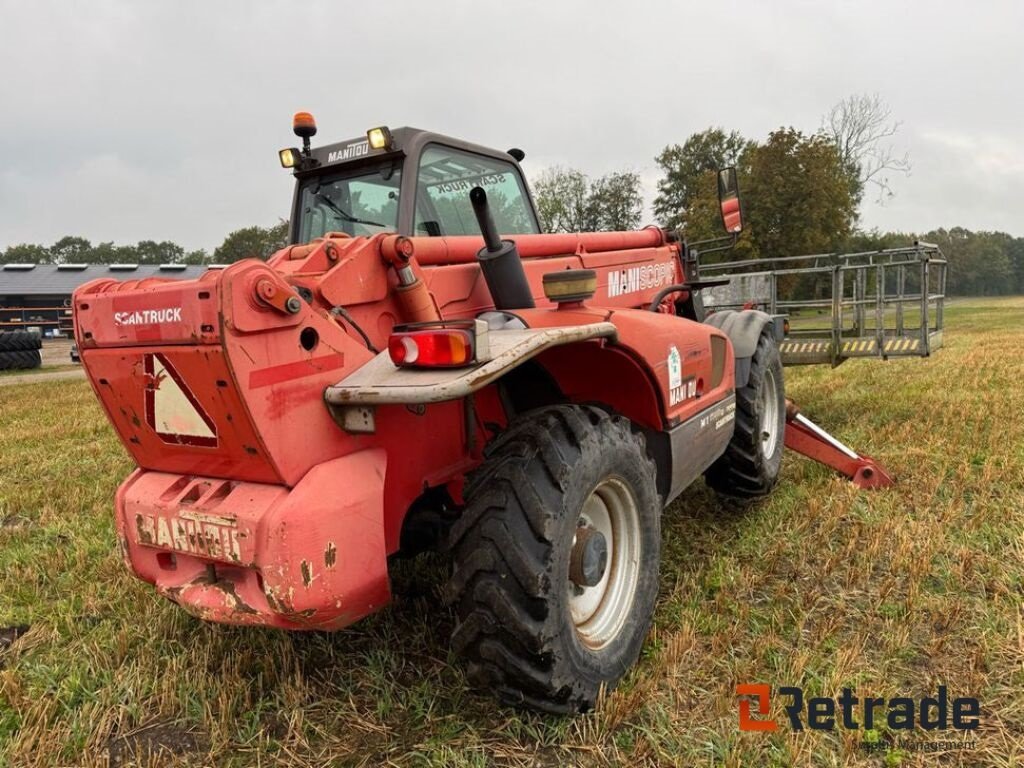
[568,477,640,649]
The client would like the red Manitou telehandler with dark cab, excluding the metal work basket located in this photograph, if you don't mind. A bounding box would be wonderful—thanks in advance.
[74,113,942,712]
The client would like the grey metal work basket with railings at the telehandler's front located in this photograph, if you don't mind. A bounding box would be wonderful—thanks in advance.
[700,242,946,366]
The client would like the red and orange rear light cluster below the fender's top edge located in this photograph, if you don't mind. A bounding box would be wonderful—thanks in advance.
[387,321,486,368]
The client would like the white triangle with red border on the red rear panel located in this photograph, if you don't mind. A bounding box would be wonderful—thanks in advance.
[144,353,217,447]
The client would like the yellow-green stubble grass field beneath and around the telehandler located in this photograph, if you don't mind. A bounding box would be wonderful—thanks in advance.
[0,298,1024,768]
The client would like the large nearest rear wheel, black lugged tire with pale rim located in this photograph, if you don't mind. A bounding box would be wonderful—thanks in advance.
[445,406,662,713]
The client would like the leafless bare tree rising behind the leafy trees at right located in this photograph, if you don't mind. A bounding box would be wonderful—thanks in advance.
[822,93,910,204]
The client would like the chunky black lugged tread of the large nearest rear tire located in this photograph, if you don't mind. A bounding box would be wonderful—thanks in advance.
[444,406,655,713]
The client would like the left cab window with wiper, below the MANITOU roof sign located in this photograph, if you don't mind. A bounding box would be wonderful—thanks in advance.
[298,163,401,243]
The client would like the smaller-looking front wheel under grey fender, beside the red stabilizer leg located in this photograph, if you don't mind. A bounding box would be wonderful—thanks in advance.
[705,334,785,499]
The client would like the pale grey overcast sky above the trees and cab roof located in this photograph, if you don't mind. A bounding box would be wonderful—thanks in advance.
[0,0,1024,249]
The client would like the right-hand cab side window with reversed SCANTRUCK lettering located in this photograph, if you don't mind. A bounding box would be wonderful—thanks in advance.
[415,145,540,237]
